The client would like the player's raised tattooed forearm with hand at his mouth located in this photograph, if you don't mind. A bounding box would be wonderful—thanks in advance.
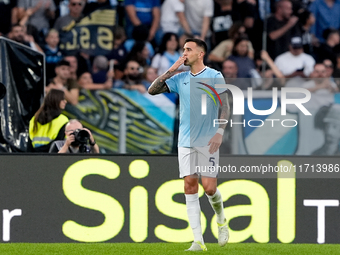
[148,56,186,95]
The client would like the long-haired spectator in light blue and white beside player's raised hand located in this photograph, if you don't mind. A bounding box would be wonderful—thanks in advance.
[151,33,181,75]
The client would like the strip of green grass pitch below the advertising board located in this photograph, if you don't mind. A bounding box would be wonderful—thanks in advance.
[0,243,340,255]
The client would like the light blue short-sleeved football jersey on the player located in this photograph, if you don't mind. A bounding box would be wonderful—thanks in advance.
[166,67,226,147]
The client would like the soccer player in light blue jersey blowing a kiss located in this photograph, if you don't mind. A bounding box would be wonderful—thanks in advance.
[148,39,229,251]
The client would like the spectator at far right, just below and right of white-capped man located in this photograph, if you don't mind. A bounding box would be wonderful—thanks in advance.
[302,63,338,94]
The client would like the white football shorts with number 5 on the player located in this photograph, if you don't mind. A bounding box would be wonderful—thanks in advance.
[178,146,220,178]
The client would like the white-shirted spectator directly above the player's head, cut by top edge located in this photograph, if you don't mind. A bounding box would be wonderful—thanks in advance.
[184,0,214,41]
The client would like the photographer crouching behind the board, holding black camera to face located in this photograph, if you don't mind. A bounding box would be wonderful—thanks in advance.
[49,119,99,153]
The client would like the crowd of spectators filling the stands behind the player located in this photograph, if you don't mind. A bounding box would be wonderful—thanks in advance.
[0,0,340,105]
